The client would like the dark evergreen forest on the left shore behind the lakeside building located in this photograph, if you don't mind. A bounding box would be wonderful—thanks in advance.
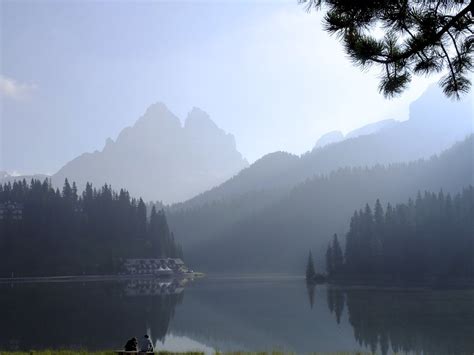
[0,179,182,276]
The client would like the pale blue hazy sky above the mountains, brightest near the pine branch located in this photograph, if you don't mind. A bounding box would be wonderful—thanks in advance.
[0,0,436,174]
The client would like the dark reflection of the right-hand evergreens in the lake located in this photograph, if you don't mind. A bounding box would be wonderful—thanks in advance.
[327,286,474,354]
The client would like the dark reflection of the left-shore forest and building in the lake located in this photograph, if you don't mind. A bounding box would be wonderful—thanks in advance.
[0,279,187,350]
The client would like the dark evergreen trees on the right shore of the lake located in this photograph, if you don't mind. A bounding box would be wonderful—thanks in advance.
[326,186,474,280]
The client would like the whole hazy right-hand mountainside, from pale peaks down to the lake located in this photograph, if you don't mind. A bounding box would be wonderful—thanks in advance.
[168,88,473,272]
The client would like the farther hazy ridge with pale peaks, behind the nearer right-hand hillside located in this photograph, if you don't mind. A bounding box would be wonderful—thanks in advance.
[167,88,473,253]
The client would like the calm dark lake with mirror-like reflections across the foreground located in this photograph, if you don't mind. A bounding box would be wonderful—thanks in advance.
[0,276,474,354]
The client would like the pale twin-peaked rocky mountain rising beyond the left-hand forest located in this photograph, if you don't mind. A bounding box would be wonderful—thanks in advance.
[52,103,248,203]
